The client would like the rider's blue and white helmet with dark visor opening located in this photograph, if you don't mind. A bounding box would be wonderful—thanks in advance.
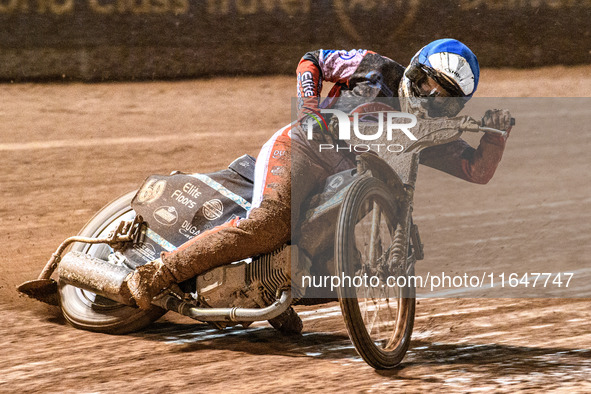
[400,38,480,116]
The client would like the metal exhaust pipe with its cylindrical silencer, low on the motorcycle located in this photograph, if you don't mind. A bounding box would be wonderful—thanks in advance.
[58,252,292,322]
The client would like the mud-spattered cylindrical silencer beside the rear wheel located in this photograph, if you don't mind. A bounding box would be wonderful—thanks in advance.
[58,252,135,305]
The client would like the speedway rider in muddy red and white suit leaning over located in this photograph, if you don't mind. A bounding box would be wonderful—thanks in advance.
[127,39,511,331]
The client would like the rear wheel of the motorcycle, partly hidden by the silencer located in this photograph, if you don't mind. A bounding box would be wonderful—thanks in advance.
[59,192,166,334]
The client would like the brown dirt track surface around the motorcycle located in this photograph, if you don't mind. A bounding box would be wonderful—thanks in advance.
[0,67,591,393]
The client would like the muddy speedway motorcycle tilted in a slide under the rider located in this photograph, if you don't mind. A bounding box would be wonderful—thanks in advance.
[18,109,504,369]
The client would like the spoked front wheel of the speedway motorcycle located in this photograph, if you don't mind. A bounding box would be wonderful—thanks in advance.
[335,177,415,369]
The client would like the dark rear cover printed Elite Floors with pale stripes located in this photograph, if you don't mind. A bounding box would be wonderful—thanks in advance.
[123,155,255,265]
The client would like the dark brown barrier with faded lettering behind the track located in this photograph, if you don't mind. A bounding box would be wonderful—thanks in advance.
[0,0,591,81]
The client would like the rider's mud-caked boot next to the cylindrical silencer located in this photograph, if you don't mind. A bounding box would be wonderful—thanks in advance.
[125,259,176,309]
